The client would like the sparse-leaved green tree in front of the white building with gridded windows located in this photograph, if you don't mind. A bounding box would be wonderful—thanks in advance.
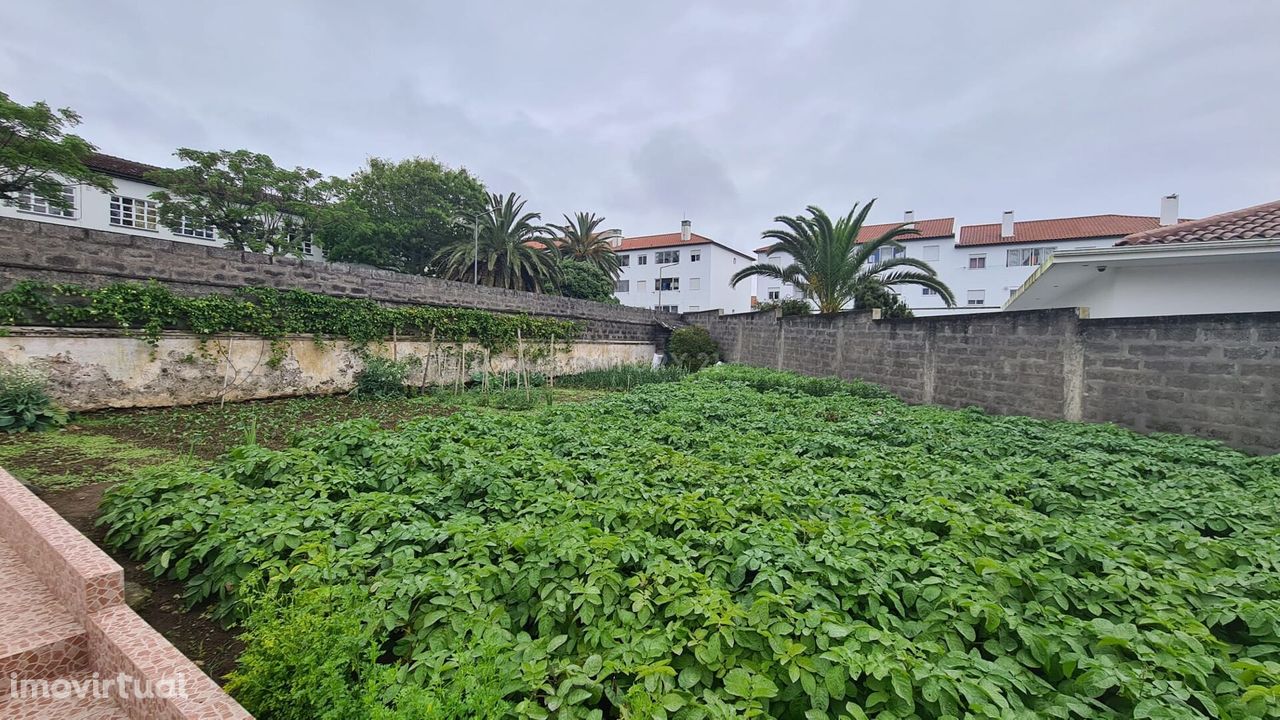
[148,147,342,255]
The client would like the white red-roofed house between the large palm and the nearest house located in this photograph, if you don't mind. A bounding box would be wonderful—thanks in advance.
[957,202,1178,309]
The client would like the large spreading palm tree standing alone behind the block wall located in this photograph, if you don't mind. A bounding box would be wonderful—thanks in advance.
[730,200,955,313]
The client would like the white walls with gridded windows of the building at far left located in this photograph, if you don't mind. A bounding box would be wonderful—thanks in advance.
[0,178,321,259]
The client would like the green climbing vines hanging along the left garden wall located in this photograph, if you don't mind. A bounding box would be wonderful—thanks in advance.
[0,281,582,352]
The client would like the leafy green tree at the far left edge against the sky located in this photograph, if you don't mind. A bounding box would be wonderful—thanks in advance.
[0,92,115,210]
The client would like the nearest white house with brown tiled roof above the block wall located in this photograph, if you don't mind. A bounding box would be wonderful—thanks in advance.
[1005,201,1280,318]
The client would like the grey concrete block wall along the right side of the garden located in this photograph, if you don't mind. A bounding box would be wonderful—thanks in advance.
[686,310,1280,452]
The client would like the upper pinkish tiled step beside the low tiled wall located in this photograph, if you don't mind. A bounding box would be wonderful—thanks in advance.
[0,538,87,676]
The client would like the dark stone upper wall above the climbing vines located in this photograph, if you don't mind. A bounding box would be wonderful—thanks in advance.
[0,218,680,345]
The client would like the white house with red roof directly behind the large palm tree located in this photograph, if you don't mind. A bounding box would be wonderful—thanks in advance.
[755,210,957,310]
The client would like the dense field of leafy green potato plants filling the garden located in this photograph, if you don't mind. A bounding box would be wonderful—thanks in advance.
[102,366,1280,720]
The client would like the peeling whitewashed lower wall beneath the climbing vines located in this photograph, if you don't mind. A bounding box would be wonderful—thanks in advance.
[0,328,653,411]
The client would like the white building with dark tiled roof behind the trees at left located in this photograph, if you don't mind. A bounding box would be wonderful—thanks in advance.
[0,154,320,259]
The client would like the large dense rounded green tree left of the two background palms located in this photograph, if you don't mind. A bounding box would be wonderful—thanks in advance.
[316,158,488,274]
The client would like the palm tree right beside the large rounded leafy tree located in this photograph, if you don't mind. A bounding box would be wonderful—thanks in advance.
[439,192,557,292]
